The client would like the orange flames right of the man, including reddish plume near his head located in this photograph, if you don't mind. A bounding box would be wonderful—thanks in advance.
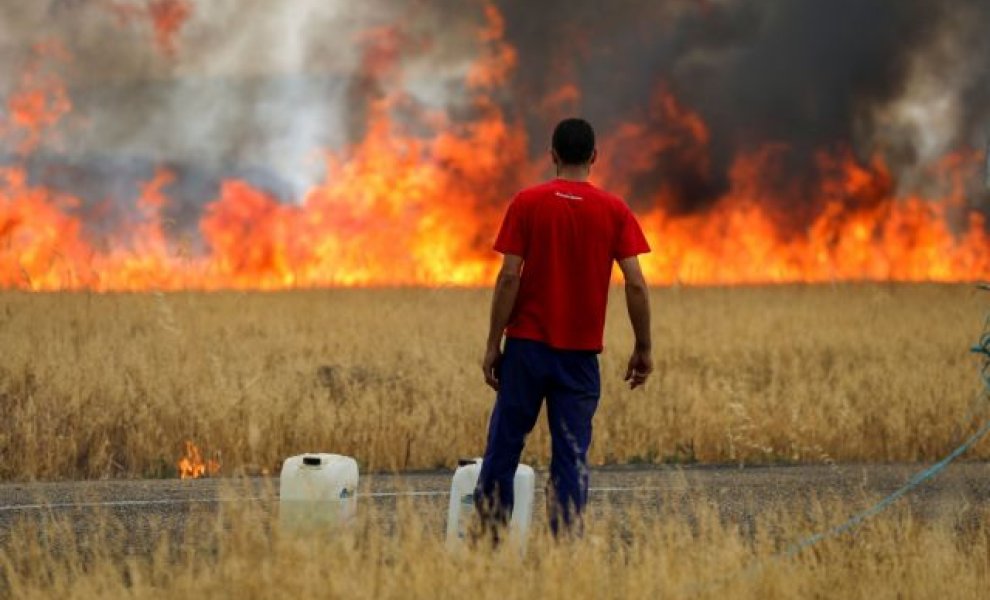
[603,89,990,284]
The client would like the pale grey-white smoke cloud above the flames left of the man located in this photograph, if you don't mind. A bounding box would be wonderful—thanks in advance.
[0,0,481,228]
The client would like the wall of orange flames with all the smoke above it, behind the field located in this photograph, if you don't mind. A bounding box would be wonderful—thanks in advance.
[0,0,990,291]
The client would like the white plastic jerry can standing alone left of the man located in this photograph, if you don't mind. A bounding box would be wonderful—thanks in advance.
[278,454,358,529]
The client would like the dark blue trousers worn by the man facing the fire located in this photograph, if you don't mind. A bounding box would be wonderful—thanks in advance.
[474,338,601,535]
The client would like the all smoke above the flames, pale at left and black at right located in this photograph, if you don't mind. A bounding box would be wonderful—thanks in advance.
[0,0,990,238]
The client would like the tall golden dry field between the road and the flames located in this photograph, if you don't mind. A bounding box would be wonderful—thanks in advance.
[0,285,990,480]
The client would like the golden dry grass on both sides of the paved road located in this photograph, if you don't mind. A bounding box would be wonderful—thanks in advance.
[0,284,990,600]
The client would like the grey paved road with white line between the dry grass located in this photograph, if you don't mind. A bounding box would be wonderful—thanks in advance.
[0,463,990,545]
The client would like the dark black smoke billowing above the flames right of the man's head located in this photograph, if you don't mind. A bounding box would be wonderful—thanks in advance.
[504,0,990,211]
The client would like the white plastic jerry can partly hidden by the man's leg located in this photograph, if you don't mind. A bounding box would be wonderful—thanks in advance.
[447,458,536,549]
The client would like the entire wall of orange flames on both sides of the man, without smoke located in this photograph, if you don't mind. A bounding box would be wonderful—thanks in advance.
[0,6,990,290]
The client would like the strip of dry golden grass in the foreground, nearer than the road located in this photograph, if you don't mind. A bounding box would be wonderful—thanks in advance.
[0,488,990,600]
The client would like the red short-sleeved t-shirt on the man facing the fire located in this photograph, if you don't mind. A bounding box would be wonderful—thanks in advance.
[495,179,650,352]
